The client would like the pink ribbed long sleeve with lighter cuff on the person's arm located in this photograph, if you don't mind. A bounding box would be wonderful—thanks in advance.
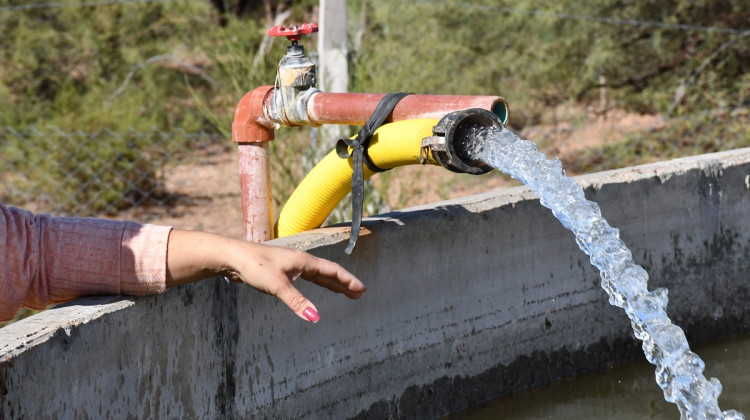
[0,203,171,321]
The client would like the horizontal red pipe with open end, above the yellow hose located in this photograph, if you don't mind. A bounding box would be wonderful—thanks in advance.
[307,92,507,125]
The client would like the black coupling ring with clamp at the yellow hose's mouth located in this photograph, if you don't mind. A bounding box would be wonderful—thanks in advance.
[419,108,503,175]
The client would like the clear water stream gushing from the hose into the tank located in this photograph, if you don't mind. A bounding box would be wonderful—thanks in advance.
[458,126,745,419]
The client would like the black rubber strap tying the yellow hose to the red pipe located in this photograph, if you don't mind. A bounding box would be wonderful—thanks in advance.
[336,92,409,255]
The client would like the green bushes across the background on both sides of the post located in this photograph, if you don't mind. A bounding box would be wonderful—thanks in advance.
[0,0,750,212]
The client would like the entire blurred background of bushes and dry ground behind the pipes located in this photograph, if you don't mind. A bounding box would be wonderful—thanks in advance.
[0,0,750,238]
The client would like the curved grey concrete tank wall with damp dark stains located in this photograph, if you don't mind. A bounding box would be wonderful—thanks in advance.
[0,149,750,419]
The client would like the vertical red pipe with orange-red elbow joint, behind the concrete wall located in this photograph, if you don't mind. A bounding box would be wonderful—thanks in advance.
[232,86,274,242]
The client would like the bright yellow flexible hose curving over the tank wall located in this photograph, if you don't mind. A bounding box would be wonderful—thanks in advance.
[275,119,439,237]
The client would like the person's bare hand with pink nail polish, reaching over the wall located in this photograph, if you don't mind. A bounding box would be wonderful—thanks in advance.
[167,230,366,323]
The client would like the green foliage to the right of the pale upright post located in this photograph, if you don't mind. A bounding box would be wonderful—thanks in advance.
[356,0,750,126]
